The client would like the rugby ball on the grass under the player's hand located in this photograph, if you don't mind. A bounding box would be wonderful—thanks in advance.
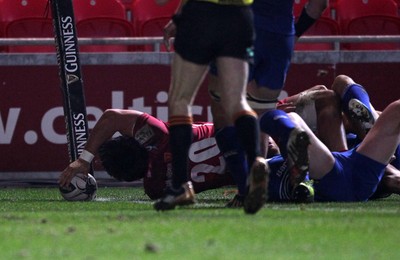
[60,173,97,201]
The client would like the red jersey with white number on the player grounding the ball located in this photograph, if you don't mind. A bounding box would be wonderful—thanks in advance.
[133,114,234,199]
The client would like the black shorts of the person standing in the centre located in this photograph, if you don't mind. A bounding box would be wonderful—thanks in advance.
[174,1,254,64]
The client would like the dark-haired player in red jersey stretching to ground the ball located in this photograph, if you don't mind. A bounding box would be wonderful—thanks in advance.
[59,109,312,204]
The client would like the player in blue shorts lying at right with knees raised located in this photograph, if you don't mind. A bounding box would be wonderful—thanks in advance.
[260,94,400,201]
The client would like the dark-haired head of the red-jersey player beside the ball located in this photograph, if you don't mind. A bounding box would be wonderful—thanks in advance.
[99,136,148,181]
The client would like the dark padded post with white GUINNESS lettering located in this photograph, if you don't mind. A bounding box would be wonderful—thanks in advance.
[50,0,93,174]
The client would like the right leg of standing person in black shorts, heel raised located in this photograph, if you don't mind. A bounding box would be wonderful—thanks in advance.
[217,57,268,214]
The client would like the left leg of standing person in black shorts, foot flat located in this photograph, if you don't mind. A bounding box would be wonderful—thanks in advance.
[154,53,208,210]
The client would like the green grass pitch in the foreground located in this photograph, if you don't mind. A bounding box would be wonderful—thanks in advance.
[0,187,400,260]
